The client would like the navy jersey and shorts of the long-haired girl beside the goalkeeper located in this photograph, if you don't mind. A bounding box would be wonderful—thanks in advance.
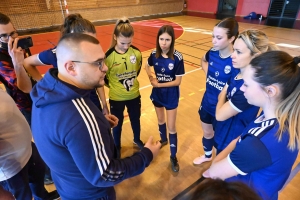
[148,50,185,108]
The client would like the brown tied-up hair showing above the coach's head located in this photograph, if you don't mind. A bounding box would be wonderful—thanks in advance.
[60,13,96,36]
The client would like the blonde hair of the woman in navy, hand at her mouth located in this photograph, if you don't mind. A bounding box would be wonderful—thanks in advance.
[238,29,279,56]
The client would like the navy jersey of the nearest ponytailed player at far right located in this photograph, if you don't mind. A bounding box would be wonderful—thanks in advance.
[227,115,298,200]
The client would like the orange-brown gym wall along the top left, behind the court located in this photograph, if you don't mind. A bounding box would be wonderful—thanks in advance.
[0,0,183,30]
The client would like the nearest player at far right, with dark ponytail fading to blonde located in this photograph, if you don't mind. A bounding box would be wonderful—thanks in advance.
[203,51,300,199]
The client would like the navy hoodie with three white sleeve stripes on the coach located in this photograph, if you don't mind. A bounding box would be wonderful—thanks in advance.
[30,68,153,200]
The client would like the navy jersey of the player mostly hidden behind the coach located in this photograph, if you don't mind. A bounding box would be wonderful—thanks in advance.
[37,47,102,110]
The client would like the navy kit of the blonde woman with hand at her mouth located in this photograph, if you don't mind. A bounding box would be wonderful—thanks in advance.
[214,76,259,151]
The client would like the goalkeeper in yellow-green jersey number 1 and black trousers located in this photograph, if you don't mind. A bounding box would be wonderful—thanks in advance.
[105,18,144,158]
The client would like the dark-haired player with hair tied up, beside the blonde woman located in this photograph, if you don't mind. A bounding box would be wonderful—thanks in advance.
[193,18,239,165]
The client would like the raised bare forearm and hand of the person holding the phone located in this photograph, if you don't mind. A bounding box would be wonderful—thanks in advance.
[8,37,32,93]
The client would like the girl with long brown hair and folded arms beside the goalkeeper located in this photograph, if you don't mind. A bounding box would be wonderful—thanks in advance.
[145,25,185,172]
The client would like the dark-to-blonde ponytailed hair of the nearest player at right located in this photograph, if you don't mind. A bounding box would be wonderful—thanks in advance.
[250,51,300,150]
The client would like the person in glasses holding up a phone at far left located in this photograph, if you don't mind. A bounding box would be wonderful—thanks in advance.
[0,13,34,124]
